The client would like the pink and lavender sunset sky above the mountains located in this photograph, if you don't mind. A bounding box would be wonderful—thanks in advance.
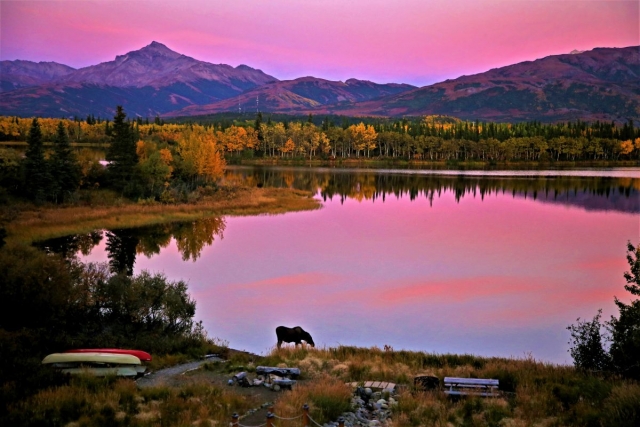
[0,0,640,86]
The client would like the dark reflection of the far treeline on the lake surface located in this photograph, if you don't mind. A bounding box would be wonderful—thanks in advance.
[225,168,640,212]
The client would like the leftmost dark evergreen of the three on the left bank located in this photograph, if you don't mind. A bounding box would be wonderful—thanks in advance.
[24,119,50,202]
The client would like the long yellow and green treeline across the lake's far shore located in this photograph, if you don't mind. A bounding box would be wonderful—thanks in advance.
[0,114,640,162]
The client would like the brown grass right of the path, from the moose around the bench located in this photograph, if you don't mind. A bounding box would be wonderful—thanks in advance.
[266,346,640,427]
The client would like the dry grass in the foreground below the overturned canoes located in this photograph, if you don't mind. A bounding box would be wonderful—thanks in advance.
[13,377,258,426]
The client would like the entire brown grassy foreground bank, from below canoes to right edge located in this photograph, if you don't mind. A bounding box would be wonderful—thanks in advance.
[12,346,640,427]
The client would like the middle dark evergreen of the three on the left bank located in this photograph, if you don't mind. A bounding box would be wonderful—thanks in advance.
[50,121,81,203]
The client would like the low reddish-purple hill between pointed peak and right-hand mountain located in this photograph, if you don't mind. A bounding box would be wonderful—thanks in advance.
[167,77,416,116]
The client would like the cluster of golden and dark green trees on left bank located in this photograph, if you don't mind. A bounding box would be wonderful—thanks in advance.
[0,107,228,203]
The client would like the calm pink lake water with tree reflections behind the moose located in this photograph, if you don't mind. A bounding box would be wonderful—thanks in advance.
[41,167,640,364]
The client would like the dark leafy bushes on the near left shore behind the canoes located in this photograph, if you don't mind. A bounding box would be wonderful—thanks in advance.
[0,245,216,418]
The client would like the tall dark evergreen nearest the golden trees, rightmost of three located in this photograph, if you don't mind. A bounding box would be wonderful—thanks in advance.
[106,105,138,189]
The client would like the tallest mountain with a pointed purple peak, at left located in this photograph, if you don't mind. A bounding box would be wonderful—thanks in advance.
[0,42,277,117]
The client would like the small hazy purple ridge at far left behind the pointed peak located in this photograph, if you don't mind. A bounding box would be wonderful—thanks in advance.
[0,60,75,92]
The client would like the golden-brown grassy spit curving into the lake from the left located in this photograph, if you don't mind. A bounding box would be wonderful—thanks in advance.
[0,186,320,243]
